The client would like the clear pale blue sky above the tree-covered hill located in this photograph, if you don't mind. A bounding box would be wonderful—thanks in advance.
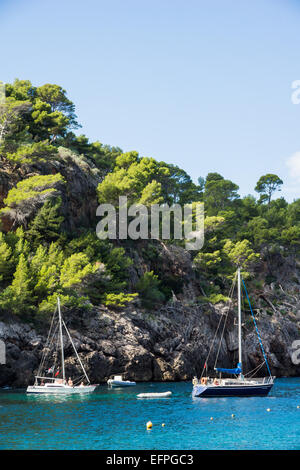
[0,0,300,201]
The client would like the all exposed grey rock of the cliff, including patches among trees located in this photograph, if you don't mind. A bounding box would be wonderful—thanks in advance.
[0,149,300,387]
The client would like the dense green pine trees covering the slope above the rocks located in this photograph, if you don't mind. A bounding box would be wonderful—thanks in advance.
[0,80,300,319]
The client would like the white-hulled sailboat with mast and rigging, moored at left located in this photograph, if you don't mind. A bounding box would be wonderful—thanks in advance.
[26,297,98,395]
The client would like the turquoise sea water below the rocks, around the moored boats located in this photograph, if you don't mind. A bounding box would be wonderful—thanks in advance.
[0,378,300,450]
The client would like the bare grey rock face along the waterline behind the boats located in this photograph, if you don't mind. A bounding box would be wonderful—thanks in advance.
[0,302,300,387]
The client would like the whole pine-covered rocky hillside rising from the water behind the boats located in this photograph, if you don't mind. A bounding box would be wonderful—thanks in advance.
[0,80,300,386]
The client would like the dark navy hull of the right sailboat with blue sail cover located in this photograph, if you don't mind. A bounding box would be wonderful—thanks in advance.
[193,383,273,398]
